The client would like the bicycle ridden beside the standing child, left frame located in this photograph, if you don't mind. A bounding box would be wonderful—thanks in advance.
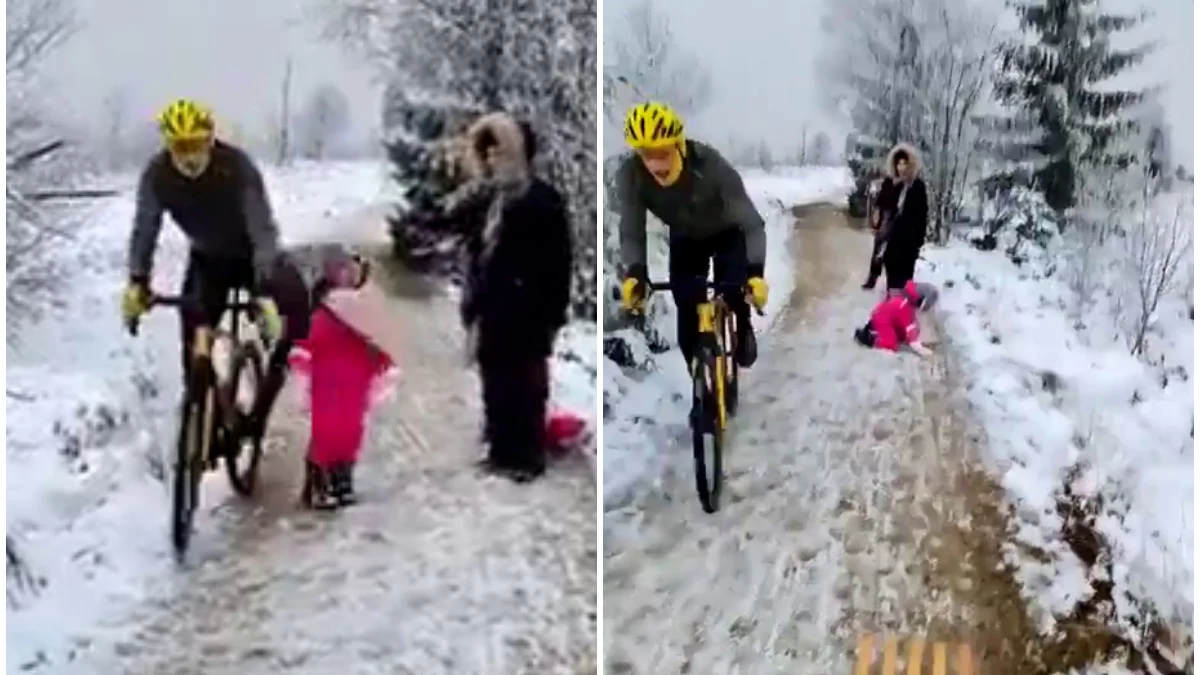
[128,289,271,560]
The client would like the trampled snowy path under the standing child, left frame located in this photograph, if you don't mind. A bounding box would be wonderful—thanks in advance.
[79,258,596,675]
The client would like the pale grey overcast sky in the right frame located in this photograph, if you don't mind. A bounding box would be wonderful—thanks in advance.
[604,0,1193,166]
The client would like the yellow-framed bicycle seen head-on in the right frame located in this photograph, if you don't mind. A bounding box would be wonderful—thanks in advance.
[647,280,763,513]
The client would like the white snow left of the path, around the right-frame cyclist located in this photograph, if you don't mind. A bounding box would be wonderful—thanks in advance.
[602,167,853,509]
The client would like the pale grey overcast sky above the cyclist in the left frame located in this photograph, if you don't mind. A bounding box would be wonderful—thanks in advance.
[49,0,379,144]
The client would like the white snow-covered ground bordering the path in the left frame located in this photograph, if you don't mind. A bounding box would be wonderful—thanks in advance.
[6,162,596,671]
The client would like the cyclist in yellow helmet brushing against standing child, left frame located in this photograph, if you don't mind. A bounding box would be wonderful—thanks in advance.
[121,100,308,436]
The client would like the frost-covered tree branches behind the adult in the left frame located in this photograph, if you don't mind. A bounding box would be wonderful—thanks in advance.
[322,0,596,316]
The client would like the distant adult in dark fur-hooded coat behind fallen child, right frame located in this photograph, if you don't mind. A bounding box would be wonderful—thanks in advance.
[871,143,929,291]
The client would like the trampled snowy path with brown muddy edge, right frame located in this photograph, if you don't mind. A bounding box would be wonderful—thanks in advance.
[605,207,1081,675]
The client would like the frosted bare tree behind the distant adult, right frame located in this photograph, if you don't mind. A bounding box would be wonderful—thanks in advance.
[822,0,995,239]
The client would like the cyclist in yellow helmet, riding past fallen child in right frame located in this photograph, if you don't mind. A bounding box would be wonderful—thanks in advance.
[617,102,767,369]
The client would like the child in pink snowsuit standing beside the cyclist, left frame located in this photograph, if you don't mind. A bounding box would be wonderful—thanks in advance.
[290,250,400,509]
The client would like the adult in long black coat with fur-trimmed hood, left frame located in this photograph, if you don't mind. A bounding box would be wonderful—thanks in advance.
[461,113,571,482]
